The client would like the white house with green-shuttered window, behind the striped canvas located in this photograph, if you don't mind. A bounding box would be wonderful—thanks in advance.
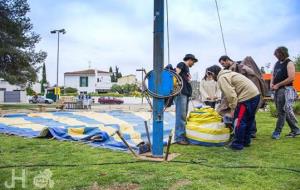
[64,69,112,93]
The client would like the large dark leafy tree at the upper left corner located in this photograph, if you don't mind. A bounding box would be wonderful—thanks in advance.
[0,0,47,85]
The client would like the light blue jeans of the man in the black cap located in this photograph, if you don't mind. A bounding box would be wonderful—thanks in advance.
[175,94,189,142]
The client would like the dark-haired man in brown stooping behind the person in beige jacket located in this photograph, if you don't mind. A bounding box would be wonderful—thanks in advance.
[218,55,267,138]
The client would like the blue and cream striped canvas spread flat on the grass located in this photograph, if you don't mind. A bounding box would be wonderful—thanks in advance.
[0,111,175,150]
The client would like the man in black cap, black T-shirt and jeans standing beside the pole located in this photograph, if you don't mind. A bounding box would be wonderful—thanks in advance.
[175,54,198,145]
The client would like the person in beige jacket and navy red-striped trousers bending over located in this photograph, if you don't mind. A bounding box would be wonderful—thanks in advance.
[207,65,260,150]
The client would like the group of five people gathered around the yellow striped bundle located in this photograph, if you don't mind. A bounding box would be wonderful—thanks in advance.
[175,46,300,150]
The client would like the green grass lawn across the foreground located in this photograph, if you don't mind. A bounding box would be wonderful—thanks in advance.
[0,113,300,190]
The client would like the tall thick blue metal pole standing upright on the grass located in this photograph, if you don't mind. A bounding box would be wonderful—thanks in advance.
[152,0,164,157]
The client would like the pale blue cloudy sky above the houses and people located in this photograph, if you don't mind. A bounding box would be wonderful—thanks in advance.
[29,0,300,85]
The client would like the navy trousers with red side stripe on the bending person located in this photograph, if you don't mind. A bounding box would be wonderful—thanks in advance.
[231,96,260,150]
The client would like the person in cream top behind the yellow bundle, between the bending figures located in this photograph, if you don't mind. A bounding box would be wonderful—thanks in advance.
[200,71,221,108]
